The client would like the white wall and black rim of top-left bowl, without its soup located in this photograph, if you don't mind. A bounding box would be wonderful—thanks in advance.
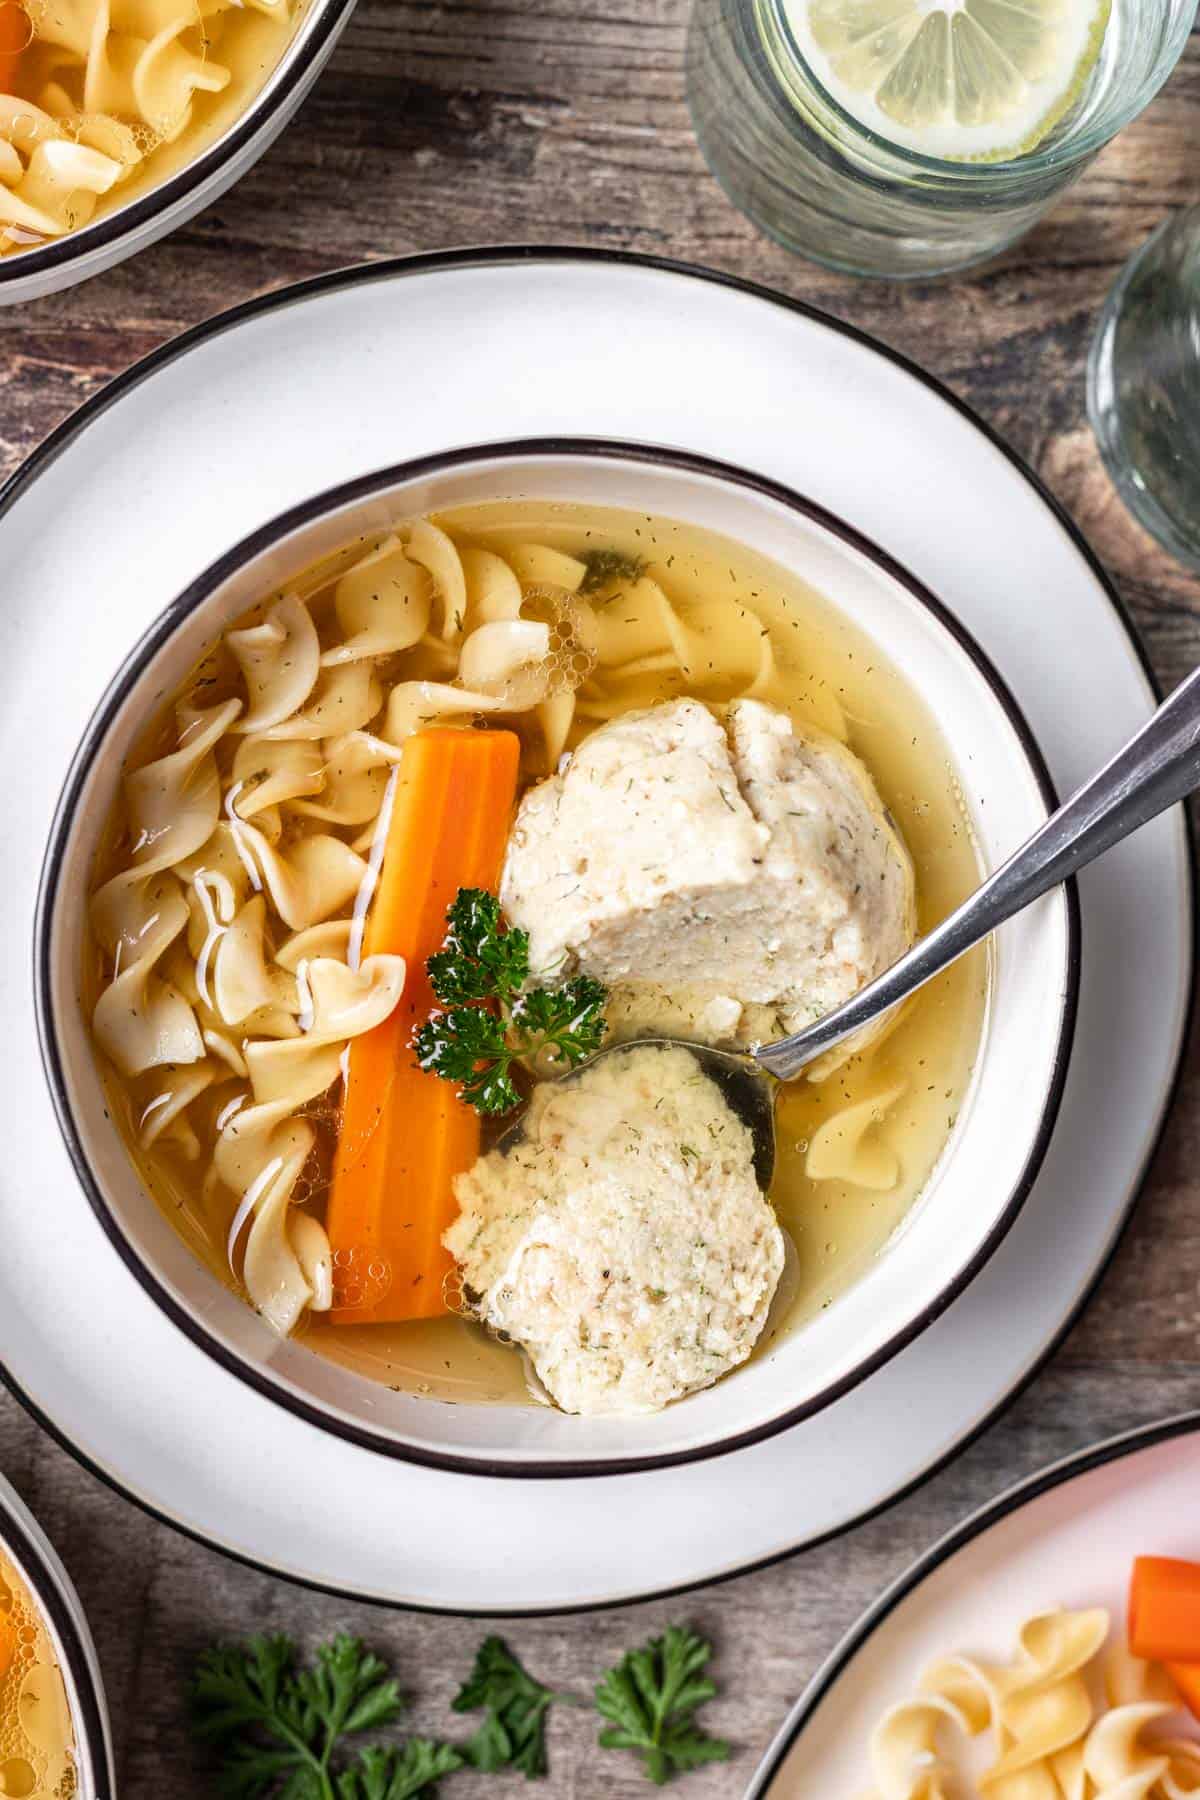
[0,0,356,306]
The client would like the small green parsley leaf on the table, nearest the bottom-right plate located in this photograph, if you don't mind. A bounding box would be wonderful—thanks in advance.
[596,1625,729,1787]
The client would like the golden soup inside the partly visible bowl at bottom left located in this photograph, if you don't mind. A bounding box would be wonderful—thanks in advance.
[0,1550,79,1800]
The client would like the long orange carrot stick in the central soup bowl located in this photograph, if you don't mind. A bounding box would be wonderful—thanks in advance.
[326,731,520,1325]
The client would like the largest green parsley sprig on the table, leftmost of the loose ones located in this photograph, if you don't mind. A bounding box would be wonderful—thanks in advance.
[191,1633,462,1800]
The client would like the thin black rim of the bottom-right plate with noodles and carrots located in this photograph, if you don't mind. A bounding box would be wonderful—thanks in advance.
[745,1411,1200,1800]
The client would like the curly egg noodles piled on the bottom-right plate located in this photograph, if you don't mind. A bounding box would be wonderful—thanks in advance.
[864,1607,1200,1800]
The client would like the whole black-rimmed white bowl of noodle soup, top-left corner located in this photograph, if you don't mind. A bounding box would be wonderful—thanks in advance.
[0,0,354,304]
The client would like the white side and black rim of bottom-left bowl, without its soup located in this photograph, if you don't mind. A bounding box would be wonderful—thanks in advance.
[0,1476,117,1800]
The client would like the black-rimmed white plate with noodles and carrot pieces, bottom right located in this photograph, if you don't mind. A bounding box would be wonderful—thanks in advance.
[747,1413,1200,1800]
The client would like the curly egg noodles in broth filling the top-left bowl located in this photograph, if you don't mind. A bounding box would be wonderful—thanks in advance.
[0,0,299,254]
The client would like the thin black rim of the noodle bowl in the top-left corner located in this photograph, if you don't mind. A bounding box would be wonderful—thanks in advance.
[0,0,358,297]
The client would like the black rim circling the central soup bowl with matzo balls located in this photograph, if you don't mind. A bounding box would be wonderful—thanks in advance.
[34,437,1079,1480]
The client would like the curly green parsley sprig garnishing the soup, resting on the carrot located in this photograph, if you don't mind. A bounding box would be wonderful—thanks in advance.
[412,887,608,1112]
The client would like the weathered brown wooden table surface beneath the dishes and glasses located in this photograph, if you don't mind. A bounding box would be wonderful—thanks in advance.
[0,0,1200,1800]
